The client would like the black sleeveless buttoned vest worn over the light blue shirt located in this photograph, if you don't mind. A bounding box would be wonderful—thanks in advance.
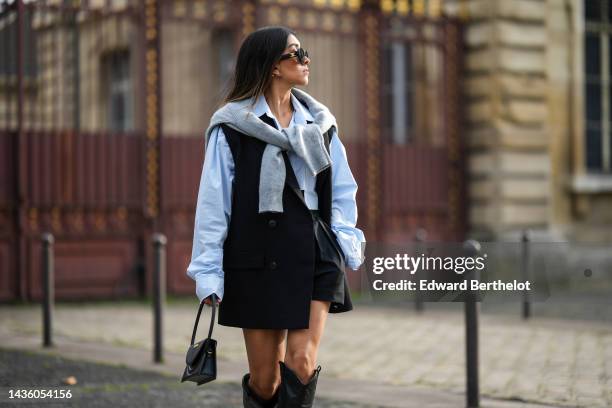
[219,114,352,329]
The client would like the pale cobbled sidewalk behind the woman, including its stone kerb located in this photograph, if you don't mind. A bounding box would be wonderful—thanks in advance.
[0,301,612,407]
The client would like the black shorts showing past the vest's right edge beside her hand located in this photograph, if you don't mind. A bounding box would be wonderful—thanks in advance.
[310,210,345,304]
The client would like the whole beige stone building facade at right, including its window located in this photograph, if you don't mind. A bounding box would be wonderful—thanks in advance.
[455,0,612,242]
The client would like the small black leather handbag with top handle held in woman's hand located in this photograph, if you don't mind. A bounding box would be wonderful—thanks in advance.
[181,293,217,385]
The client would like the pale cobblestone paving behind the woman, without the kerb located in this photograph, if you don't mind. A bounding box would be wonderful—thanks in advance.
[0,300,612,408]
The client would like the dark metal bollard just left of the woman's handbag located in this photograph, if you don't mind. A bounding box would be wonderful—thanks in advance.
[153,233,168,363]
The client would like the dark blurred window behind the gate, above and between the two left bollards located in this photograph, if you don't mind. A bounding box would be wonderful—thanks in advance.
[101,50,134,132]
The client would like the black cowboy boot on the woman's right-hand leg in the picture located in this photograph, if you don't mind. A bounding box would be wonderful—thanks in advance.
[278,361,321,408]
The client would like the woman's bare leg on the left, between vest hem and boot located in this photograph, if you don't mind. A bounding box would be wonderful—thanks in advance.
[242,329,287,399]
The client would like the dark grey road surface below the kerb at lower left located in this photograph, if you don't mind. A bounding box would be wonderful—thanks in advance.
[0,349,374,408]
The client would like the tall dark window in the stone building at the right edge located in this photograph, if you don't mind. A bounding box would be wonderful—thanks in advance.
[584,0,612,173]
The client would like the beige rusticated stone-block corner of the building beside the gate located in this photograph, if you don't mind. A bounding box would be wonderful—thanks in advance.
[463,0,552,239]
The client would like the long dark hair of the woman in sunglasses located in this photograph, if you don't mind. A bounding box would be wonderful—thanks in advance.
[223,26,296,108]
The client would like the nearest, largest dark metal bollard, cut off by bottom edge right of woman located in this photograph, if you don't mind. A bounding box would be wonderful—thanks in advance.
[463,239,480,408]
